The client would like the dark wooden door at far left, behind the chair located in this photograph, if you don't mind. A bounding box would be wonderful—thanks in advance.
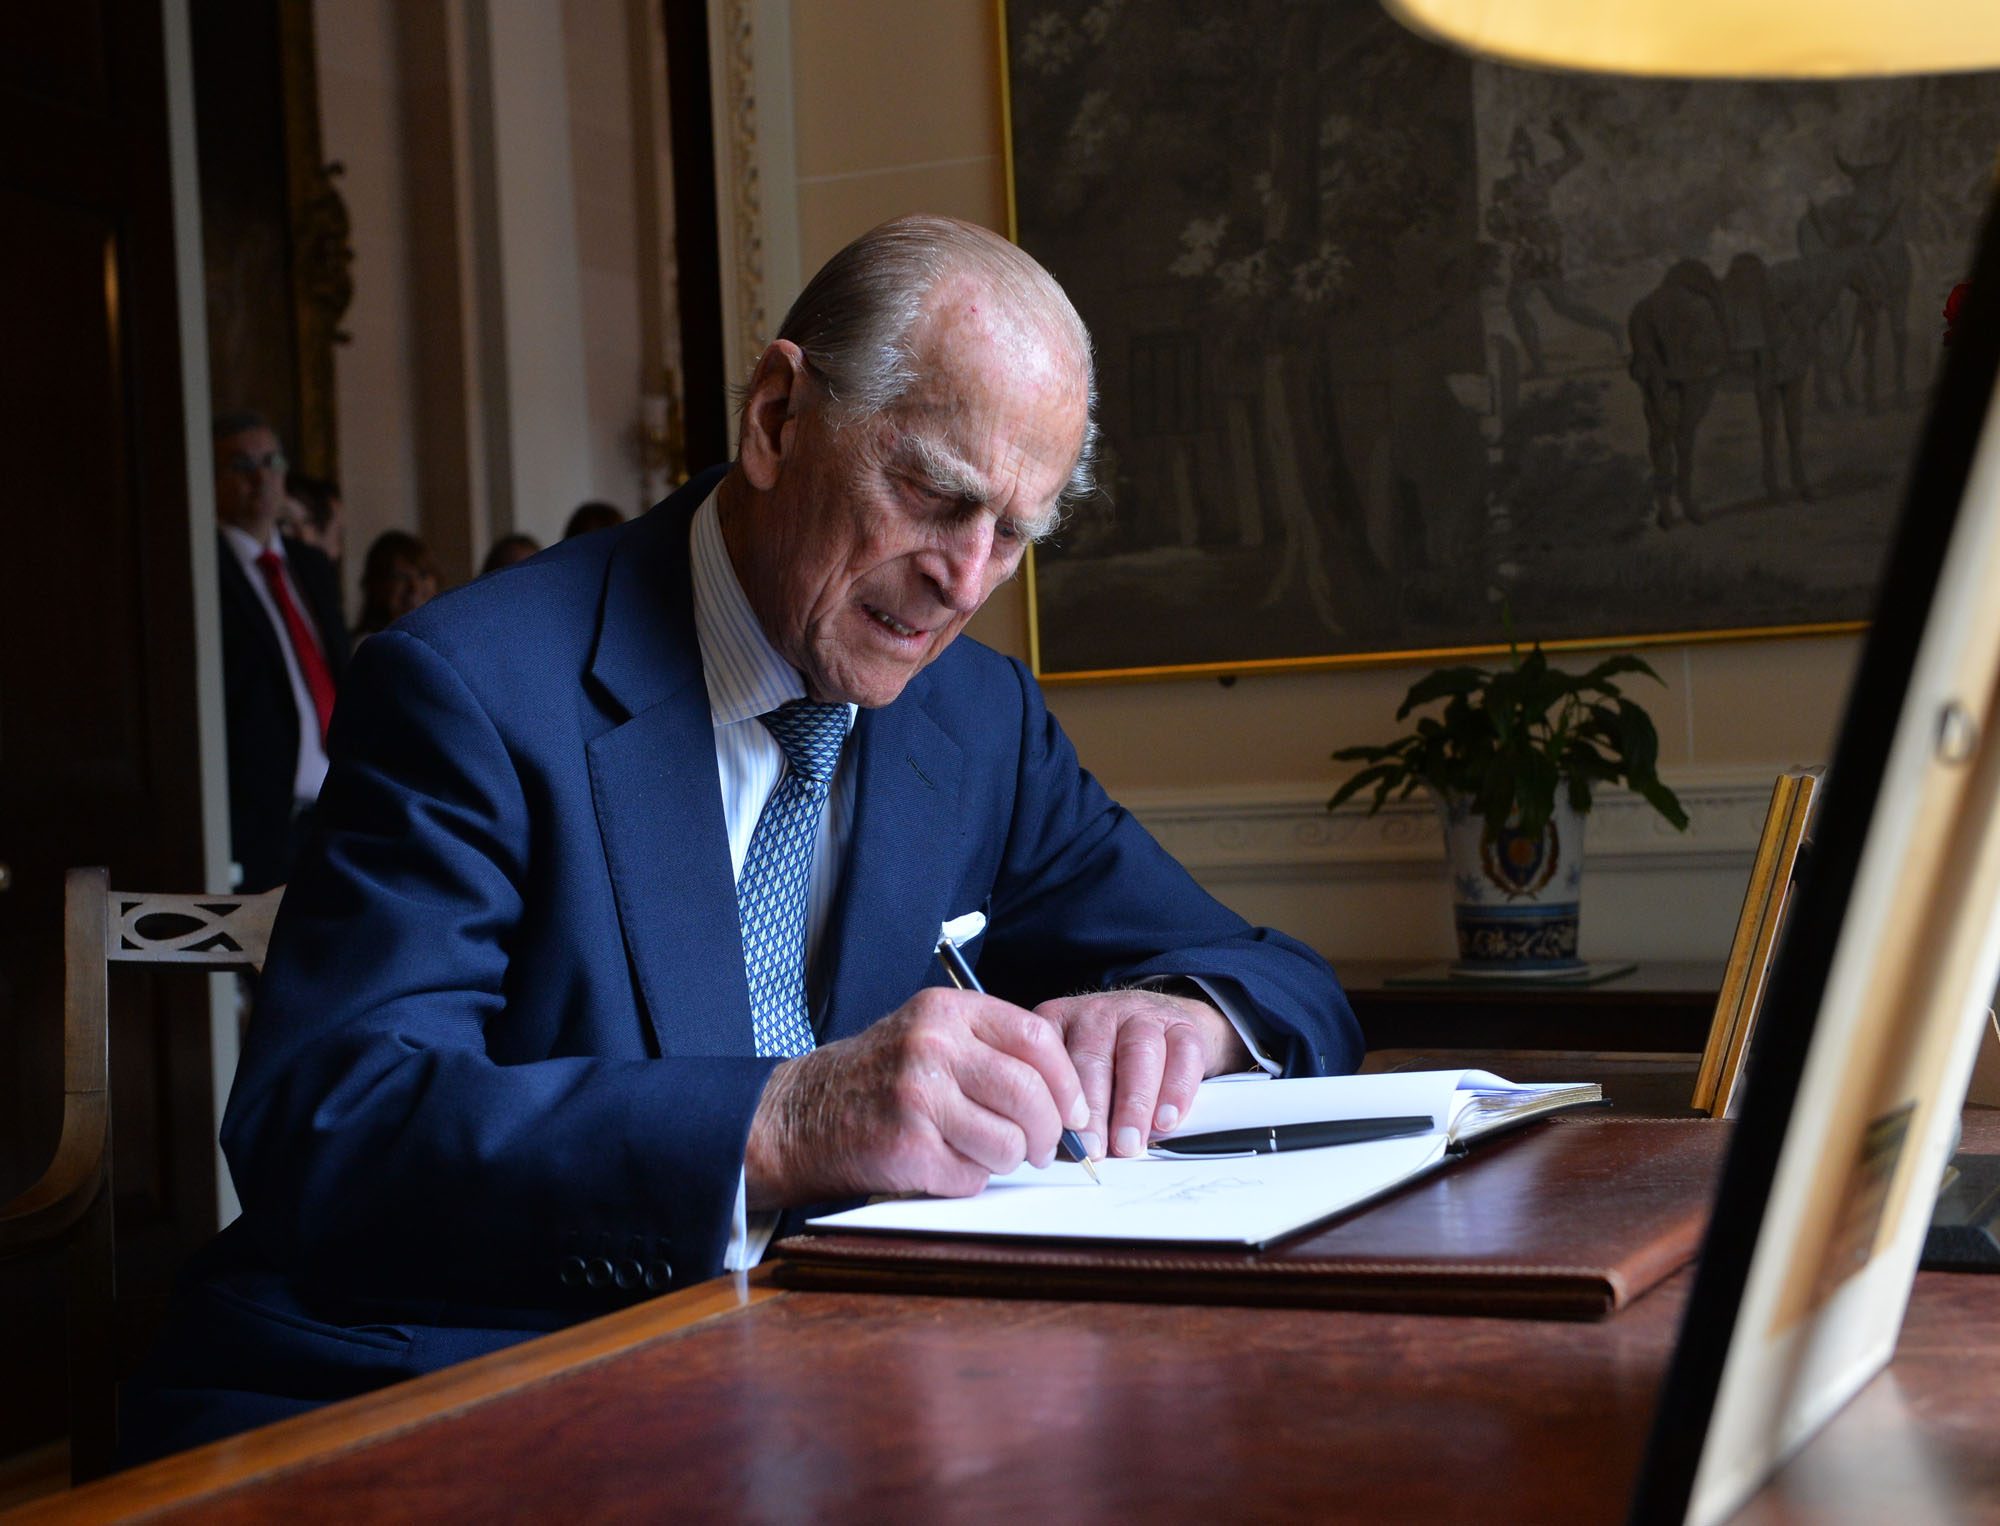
[0,0,216,1454]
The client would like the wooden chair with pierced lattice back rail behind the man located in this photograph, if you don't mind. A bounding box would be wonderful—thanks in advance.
[0,868,284,1482]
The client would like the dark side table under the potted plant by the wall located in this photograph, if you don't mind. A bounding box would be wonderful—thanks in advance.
[1332,958,1722,1054]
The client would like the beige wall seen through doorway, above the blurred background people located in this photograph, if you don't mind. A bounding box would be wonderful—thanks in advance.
[314,0,662,596]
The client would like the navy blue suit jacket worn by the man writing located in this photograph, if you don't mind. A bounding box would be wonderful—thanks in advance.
[129,476,1360,1448]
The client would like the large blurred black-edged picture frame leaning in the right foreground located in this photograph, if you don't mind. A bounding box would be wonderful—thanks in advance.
[1630,206,2000,1526]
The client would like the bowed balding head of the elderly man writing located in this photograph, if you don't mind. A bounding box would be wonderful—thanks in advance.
[716,218,1092,706]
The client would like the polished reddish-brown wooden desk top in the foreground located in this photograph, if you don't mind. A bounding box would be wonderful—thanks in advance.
[24,1114,2000,1522]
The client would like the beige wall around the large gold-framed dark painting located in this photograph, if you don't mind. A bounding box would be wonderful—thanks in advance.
[792,0,1856,958]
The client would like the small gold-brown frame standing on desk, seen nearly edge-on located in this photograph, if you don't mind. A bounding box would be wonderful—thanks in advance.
[1690,768,1822,1118]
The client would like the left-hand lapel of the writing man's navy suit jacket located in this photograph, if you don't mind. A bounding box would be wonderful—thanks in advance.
[586,474,752,1054]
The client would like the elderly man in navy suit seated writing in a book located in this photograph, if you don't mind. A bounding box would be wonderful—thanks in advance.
[129,218,1360,1450]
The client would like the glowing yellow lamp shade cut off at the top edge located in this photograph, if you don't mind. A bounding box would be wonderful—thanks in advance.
[1382,0,2000,80]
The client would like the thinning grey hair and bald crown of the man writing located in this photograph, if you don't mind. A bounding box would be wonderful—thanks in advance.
[752,214,1098,502]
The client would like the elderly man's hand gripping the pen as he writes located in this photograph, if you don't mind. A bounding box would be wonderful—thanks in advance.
[744,986,1090,1210]
